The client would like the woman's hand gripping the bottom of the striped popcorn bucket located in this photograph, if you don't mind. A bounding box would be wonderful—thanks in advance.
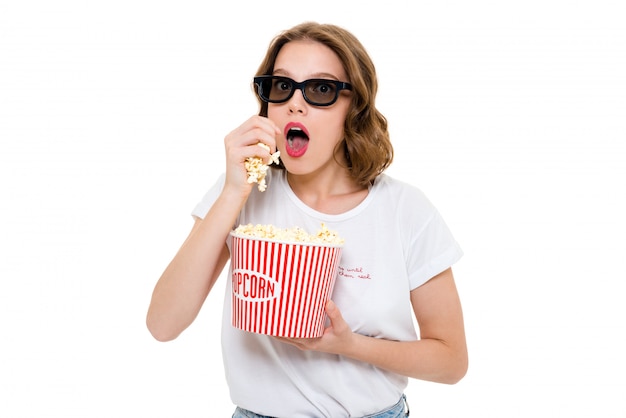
[275,300,354,354]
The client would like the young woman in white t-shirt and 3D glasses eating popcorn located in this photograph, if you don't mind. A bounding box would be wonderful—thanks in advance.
[147,23,468,418]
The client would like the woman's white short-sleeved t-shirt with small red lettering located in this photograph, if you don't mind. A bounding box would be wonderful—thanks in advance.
[192,169,462,418]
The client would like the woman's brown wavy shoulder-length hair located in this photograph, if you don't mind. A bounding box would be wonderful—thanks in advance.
[256,22,393,186]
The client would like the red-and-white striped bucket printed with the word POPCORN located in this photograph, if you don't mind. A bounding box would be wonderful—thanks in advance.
[231,233,342,338]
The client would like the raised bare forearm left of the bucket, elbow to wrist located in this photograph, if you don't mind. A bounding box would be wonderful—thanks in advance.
[146,188,243,341]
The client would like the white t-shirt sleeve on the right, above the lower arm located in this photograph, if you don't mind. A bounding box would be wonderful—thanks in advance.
[407,210,463,289]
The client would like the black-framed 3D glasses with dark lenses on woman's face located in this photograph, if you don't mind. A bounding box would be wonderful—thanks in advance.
[254,75,352,106]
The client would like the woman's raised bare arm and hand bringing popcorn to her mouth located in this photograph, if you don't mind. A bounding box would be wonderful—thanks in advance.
[146,116,278,341]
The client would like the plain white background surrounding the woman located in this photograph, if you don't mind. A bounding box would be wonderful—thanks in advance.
[0,0,626,418]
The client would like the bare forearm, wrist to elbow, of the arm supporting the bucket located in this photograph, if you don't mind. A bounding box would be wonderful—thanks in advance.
[341,334,467,384]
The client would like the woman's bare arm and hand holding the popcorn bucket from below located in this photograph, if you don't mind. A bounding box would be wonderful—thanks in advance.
[280,269,468,384]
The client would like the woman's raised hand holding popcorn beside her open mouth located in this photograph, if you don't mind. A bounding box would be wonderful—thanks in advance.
[224,115,280,199]
